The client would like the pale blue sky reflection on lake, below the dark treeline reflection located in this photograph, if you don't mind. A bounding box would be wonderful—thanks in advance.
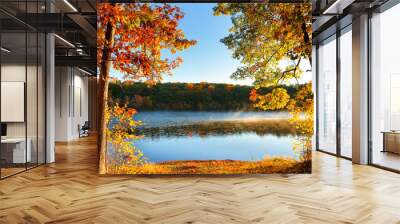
[136,133,298,162]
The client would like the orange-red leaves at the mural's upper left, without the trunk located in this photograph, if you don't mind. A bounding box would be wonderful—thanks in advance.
[97,3,196,84]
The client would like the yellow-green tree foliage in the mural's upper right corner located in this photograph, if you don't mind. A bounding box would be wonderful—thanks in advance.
[214,2,312,89]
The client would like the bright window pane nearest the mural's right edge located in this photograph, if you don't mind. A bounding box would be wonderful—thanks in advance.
[318,36,336,153]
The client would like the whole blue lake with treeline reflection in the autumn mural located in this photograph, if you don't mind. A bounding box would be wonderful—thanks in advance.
[130,111,299,163]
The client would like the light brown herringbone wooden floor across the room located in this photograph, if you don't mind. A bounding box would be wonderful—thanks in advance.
[0,138,400,224]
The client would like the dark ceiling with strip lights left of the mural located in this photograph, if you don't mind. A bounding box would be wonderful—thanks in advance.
[0,0,97,74]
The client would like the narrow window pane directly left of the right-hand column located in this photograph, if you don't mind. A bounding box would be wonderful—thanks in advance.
[340,30,352,158]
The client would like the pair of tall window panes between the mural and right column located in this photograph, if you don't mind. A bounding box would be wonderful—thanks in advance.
[316,25,352,159]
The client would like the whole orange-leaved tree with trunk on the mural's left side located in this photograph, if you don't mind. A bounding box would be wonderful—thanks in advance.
[97,3,195,174]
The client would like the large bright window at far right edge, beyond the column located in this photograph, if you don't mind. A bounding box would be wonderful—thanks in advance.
[371,4,400,170]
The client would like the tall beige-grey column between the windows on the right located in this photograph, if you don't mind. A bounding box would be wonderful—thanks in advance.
[352,14,368,164]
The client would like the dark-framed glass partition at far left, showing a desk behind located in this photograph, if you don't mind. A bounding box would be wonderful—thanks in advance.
[0,1,45,179]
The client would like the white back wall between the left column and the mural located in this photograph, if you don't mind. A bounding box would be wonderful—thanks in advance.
[55,67,89,141]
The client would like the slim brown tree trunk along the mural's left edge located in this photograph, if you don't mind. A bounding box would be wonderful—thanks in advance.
[97,19,115,174]
